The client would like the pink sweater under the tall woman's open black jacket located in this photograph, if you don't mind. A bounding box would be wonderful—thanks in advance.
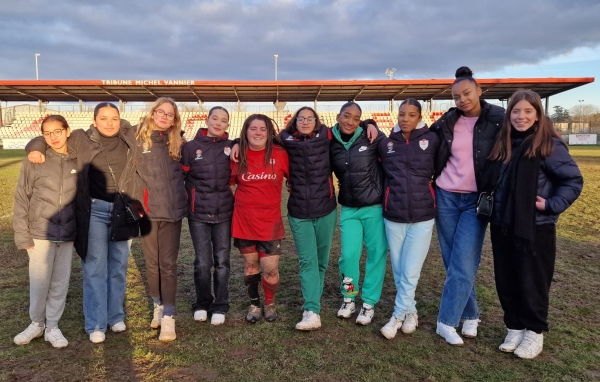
[436,116,478,193]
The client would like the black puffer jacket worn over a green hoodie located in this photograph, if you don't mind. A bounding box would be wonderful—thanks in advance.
[329,124,385,207]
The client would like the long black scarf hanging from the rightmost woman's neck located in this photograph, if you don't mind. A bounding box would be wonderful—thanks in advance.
[501,128,540,255]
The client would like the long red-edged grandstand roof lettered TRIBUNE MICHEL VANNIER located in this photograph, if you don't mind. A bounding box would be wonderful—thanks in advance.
[0,77,594,102]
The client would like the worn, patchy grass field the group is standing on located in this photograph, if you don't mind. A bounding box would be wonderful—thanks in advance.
[0,147,600,381]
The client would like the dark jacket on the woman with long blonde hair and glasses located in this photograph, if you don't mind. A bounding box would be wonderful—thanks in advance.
[136,130,187,222]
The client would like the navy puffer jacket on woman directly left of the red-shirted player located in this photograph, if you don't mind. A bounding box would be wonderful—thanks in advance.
[181,129,233,223]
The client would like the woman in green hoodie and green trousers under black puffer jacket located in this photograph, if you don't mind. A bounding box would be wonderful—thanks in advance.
[329,102,388,325]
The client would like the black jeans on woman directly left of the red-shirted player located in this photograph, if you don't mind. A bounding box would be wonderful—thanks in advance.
[188,220,231,314]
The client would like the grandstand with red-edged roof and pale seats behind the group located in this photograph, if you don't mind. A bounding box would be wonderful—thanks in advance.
[0,78,594,144]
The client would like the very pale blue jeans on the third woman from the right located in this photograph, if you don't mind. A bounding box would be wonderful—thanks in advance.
[383,219,434,320]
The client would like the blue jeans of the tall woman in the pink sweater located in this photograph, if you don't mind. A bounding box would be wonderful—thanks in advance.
[436,187,487,327]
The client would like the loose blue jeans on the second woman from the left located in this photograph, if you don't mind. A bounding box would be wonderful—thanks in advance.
[82,199,131,334]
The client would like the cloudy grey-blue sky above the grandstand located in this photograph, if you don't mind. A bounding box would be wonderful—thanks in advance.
[0,0,600,108]
